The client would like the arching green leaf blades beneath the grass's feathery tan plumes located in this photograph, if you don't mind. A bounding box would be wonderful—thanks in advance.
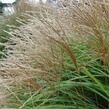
[6,37,109,109]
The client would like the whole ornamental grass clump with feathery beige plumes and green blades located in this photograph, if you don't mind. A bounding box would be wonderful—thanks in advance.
[0,0,109,109]
